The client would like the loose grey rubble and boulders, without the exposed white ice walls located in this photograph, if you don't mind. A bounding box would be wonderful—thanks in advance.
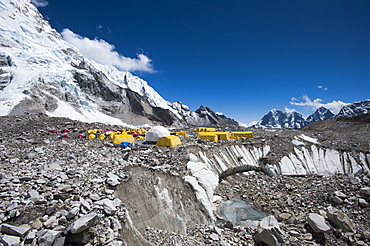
[0,115,370,246]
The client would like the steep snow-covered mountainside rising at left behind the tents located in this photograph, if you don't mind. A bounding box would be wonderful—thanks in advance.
[0,0,237,126]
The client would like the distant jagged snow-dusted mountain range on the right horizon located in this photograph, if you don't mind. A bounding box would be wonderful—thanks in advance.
[253,99,370,129]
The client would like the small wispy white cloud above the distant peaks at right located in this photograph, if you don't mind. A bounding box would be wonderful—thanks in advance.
[290,95,348,114]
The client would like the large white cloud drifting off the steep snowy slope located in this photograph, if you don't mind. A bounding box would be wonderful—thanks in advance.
[62,29,154,72]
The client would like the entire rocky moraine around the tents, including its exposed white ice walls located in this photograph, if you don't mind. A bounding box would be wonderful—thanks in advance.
[0,114,370,246]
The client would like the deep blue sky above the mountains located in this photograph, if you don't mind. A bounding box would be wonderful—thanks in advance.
[33,0,370,123]
